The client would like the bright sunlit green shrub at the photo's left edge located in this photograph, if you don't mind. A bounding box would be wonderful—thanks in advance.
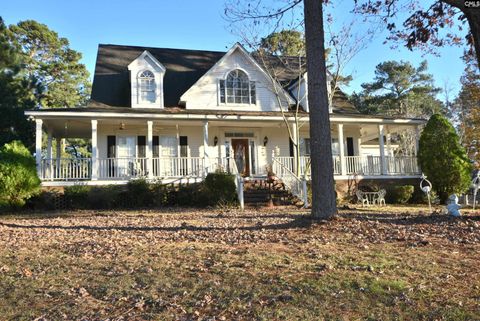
[0,141,40,208]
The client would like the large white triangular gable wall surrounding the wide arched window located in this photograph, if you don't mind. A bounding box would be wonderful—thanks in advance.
[180,44,294,111]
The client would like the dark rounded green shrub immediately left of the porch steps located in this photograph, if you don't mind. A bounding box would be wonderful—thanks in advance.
[205,172,237,205]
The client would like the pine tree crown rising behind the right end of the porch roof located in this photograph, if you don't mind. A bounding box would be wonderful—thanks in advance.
[352,61,443,117]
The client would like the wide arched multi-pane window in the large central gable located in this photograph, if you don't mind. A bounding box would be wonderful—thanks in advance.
[220,69,256,104]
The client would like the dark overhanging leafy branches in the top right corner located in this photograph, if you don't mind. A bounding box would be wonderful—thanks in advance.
[355,0,480,67]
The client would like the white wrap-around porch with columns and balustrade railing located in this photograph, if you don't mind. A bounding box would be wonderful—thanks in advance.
[30,111,420,186]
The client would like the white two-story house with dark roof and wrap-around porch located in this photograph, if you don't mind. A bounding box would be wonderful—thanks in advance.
[26,44,424,194]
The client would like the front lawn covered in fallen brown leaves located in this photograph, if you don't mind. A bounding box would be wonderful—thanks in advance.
[0,207,480,320]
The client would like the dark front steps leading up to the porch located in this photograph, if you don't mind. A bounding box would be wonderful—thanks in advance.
[243,179,298,207]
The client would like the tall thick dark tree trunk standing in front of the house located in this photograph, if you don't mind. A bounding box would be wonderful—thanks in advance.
[304,0,337,219]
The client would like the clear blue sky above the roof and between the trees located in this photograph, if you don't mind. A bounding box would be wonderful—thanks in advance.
[0,0,464,99]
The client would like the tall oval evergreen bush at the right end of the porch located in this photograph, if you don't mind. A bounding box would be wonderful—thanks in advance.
[418,114,472,202]
